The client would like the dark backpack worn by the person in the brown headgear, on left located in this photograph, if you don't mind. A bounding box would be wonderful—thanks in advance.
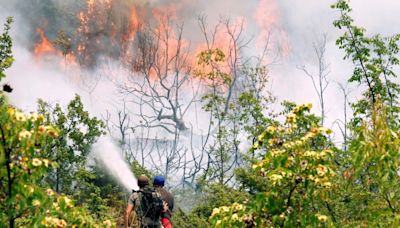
[137,187,164,223]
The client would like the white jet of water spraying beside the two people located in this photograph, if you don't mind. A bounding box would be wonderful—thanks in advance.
[91,136,139,191]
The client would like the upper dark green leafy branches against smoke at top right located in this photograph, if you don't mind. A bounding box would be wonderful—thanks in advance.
[332,0,400,126]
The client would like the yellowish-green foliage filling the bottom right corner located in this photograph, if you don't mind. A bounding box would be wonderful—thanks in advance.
[336,103,400,227]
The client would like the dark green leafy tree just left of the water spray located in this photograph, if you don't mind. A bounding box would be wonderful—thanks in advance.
[38,96,104,194]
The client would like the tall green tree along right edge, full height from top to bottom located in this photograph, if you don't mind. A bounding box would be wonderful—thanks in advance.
[332,0,400,226]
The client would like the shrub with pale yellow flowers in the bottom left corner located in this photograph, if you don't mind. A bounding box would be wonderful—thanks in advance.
[0,95,113,227]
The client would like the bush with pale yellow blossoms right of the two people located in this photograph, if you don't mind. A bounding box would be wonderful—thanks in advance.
[210,104,335,227]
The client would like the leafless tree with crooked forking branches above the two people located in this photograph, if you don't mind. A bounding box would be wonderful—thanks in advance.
[120,13,198,180]
